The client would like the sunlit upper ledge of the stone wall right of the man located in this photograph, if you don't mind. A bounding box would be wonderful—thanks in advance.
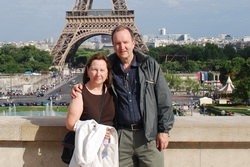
[171,116,250,142]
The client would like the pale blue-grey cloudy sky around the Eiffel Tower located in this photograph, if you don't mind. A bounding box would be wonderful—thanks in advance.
[0,0,250,42]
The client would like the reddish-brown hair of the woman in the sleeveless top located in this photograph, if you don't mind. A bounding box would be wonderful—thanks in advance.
[83,53,112,88]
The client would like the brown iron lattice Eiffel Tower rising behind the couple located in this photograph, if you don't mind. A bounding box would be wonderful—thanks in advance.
[52,0,148,67]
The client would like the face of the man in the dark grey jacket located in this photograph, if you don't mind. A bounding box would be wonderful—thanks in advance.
[113,29,135,61]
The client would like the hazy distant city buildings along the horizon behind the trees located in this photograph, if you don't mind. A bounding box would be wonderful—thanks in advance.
[0,27,250,51]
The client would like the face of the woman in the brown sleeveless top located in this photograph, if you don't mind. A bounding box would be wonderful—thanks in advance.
[88,60,108,84]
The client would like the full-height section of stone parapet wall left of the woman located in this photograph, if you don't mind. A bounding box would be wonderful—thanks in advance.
[0,116,67,167]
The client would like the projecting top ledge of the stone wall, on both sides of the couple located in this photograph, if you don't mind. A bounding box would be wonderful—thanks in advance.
[0,116,250,142]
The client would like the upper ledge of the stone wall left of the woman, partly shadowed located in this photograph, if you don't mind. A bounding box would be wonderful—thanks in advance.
[0,116,67,141]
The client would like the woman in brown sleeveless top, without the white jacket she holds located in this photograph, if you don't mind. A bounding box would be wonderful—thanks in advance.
[66,53,115,130]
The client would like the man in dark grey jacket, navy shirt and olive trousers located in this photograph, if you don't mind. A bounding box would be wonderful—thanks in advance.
[73,26,174,167]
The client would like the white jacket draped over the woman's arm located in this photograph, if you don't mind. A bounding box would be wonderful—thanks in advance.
[69,120,119,167]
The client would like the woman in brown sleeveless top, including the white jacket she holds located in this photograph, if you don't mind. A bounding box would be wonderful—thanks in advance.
[66,53,118,167]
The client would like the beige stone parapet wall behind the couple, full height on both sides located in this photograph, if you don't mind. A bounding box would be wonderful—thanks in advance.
[0,116,250,167]
